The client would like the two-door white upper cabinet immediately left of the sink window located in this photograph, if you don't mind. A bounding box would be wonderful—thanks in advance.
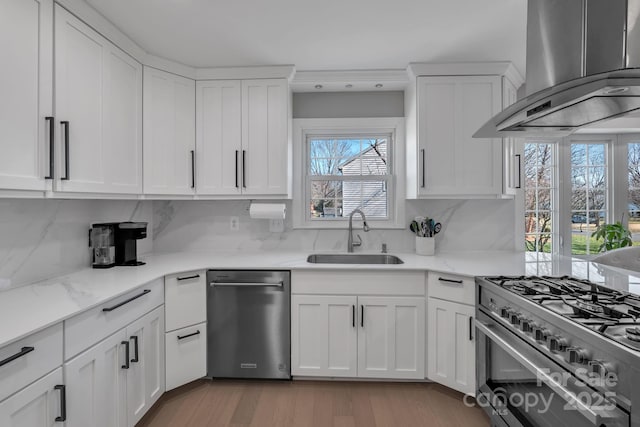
[196,79,291,197]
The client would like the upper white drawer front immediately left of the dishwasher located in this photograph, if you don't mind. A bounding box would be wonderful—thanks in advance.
[164,270,207,332]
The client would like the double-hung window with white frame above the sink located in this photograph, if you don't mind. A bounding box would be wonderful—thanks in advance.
[294,118,404,228]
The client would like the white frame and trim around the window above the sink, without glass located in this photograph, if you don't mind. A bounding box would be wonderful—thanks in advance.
[293,117,406,229]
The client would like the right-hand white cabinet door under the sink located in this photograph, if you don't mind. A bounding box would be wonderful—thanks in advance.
[358,297,425,379]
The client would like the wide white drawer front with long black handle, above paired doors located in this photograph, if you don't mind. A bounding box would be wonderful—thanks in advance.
[64,278,164,360]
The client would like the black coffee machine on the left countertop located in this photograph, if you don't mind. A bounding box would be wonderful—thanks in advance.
[89,221,147,268]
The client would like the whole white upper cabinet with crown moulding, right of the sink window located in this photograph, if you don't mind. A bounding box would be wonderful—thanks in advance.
[406,63,524,198]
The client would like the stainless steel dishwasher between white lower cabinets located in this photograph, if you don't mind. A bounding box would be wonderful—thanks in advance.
[207,270,291,379]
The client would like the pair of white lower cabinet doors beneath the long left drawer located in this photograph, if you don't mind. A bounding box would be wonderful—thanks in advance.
[64,306,164,427]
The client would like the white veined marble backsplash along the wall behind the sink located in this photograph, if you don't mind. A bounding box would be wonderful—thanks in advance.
[153,200,515,252]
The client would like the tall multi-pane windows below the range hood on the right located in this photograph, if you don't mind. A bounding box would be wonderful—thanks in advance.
[524,134,640,258]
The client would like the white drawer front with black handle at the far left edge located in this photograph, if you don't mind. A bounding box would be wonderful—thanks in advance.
[0,322,62,401]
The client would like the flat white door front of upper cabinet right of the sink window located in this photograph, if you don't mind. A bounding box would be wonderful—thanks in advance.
[417,76,502,196]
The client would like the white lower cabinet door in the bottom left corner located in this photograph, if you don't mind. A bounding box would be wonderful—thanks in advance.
[0,368,64,427]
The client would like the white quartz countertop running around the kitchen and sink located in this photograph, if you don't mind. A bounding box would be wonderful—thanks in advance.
[0,251,640,347]
